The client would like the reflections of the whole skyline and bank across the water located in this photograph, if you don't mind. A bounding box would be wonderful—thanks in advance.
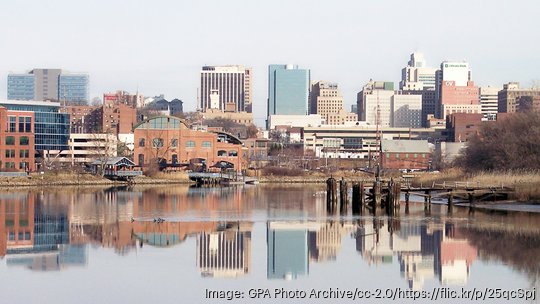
[0,186,540,289]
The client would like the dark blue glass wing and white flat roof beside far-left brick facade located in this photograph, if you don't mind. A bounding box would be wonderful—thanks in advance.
[0,100,69,151]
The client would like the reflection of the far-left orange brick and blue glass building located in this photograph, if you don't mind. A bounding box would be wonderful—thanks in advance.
[0,192,88,271]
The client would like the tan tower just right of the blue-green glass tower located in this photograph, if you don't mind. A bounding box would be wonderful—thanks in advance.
[309,81,358,125]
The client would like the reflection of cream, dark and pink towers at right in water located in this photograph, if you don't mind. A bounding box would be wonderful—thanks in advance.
[356,219,478,289]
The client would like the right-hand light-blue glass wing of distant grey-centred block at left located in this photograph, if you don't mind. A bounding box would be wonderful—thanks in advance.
[58,74,89,105]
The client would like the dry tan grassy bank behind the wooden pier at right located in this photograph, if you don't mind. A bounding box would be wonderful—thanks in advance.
[413,169,540,201]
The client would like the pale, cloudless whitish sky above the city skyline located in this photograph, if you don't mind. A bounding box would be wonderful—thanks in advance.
[0,0,540,126]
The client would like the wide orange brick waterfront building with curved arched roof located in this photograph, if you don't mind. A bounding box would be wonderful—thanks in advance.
[134,116,243,171]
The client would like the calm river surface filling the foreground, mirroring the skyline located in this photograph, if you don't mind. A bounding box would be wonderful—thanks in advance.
[0,185,540,303]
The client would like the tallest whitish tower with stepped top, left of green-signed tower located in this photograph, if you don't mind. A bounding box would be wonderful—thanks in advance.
[399,53,437,127]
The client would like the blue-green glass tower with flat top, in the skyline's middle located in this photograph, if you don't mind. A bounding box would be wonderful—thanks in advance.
[268,64,310,116]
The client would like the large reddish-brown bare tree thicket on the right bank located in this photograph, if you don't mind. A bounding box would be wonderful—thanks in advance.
[456,112,540,171]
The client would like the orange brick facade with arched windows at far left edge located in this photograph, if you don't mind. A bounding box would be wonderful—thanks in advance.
[0,107,36,171]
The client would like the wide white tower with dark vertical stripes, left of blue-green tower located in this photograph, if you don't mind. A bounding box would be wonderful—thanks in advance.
[199,65,252,112]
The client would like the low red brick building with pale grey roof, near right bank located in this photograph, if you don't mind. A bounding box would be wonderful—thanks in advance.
[381,140,431,170]
